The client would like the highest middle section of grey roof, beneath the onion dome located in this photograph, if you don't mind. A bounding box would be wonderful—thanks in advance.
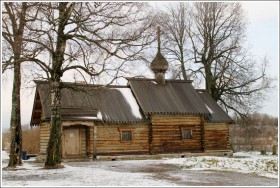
[128,78,209,115]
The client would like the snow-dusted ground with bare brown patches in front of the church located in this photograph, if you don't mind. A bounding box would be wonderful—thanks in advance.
[2,152,278,187]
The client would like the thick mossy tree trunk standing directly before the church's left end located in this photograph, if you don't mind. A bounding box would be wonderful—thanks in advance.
[45,2,70,168]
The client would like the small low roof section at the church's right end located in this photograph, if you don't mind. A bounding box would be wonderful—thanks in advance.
[197,90,233,123]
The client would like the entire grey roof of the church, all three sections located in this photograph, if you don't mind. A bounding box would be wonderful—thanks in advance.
[31,78,233,124]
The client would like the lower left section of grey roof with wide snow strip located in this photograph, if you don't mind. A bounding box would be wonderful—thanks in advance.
[33,82,145,123]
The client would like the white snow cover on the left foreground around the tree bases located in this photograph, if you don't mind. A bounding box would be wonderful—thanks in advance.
[2,151,176,187]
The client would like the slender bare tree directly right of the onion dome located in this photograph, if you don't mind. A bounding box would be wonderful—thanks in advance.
[157,2,189,80]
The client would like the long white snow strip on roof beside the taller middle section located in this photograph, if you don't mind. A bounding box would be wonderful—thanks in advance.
[116,88,142,119]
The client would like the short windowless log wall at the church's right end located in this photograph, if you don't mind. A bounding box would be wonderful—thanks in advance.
[204,123,229,150]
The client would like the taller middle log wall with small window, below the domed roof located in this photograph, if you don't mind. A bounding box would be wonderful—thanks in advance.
[151,115,202,153]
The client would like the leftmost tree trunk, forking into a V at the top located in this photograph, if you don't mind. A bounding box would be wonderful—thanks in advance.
[4,2,28,168]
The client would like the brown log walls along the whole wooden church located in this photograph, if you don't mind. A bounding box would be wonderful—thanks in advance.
[37,115,229,155]
